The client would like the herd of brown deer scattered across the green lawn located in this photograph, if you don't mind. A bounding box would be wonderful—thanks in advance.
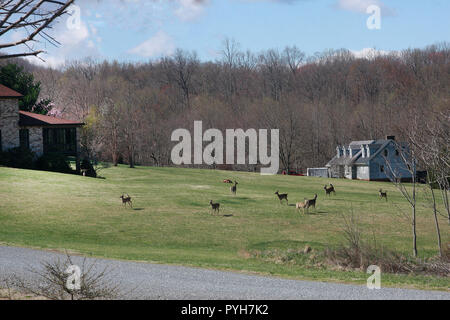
[120,179,387,213]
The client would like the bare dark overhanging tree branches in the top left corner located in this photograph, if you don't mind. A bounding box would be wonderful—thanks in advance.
[0,0,75,59]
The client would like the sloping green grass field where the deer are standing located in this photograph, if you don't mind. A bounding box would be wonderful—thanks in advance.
[0,166,450,290]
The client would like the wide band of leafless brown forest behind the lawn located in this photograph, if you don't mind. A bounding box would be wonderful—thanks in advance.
[0,39,450,172]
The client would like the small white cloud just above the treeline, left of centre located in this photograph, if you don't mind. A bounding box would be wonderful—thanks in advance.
[128,31,175,57]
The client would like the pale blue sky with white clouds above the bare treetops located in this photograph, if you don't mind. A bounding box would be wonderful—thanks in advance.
[7,0,450,67]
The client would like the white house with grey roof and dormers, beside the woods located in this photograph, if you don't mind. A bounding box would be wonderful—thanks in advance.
[326,136,412,181]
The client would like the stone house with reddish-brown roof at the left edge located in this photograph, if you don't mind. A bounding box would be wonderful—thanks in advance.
[0,84,84,171]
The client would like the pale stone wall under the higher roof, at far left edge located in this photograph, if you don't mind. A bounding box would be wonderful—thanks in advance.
[0,98,20,150]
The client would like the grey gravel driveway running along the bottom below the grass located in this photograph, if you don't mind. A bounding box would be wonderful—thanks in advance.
[0,246,450,300]
